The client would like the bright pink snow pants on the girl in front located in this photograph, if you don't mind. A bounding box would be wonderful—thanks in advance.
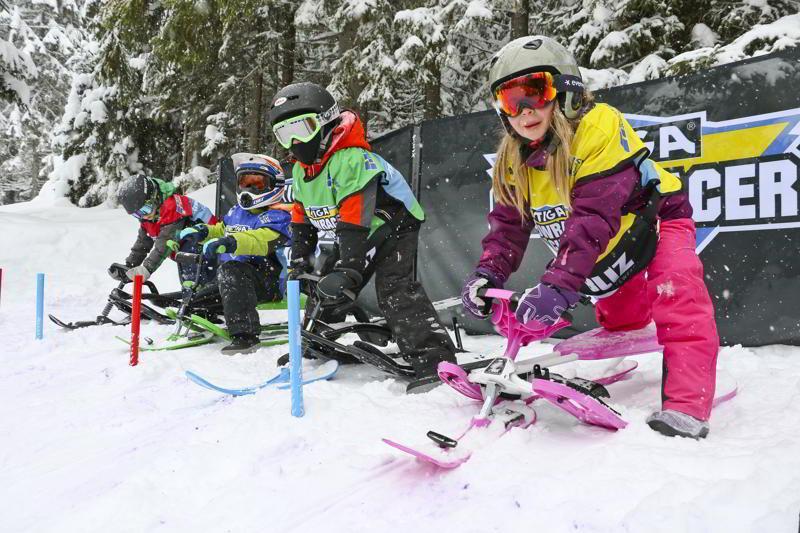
[595,218,719,420]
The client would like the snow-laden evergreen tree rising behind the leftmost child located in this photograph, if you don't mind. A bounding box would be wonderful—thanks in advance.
[51,1,173,206]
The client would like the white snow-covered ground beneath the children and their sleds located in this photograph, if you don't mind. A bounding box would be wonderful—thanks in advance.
[0,190,800,533]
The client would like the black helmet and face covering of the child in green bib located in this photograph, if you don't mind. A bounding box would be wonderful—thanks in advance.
[269,82,339,165]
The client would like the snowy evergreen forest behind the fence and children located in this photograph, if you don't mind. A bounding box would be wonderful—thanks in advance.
[0,0,800,206]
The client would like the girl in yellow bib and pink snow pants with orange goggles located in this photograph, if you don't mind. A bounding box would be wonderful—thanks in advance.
[462,36,719,438]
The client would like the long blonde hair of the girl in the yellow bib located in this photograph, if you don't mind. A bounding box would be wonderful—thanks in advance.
[492,89,594,220]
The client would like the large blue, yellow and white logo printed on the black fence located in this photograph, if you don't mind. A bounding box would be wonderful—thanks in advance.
[484,108,800,253]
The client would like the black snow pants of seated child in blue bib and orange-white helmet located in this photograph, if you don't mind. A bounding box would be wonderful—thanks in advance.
[217,257,282,335]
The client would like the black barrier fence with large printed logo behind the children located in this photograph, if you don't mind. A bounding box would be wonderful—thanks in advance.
[218,48,800,346]
